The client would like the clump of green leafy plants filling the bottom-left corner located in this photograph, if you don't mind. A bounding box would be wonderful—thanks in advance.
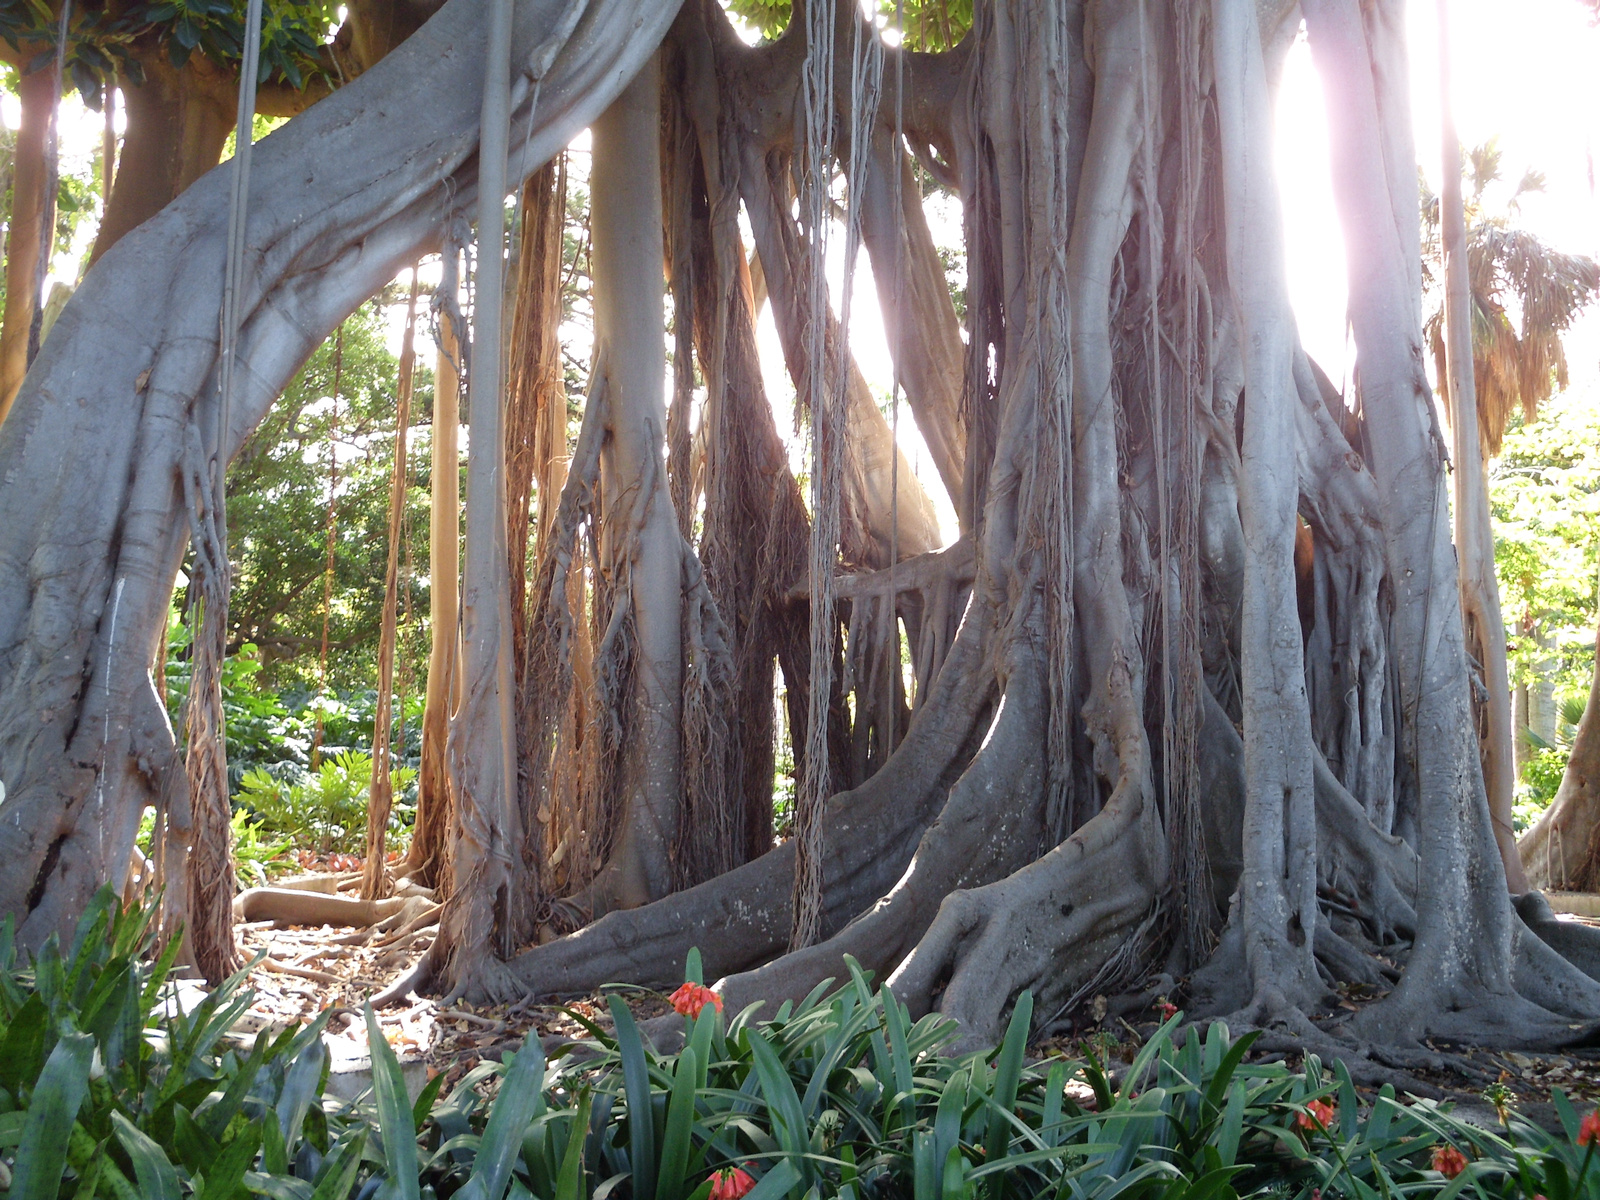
[0,888,350,1200]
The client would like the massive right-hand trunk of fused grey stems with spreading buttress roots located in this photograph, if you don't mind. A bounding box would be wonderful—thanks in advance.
[467,0,1600,1050]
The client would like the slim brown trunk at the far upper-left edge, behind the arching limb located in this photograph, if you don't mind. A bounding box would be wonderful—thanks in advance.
[0,66,56,422]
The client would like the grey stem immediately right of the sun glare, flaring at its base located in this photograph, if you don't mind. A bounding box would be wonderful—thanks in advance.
[1302,0,1600,1042]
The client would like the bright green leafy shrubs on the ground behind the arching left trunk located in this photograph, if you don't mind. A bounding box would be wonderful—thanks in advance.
[235,750,416,854]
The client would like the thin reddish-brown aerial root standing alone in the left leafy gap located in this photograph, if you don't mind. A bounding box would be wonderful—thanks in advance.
[362,267,418,899]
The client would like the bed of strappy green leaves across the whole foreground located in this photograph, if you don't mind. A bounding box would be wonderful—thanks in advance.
[0,915,1600,1200]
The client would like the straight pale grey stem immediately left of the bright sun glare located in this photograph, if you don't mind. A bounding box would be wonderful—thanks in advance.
[1211,0,1322,1013]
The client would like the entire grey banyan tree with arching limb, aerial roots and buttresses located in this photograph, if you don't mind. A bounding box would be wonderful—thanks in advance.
[0,0,1600,1072]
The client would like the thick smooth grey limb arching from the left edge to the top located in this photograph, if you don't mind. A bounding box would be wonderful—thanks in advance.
[0,0,677,946]
